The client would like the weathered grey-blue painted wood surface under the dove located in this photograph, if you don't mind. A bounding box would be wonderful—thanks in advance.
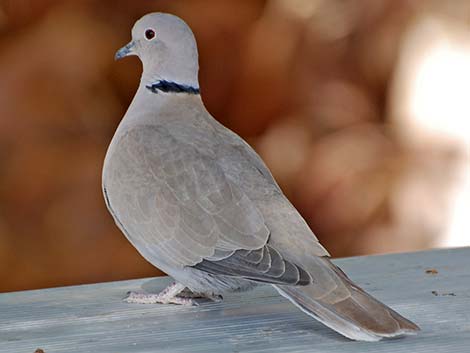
[0,248,470,353]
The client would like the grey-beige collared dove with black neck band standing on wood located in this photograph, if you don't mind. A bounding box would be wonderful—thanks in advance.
[102,13,420,341]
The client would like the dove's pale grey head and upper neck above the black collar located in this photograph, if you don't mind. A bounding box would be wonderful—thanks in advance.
[115,13,199,87]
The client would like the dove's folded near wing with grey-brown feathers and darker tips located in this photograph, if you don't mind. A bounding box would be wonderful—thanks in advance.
[104,125,310,284]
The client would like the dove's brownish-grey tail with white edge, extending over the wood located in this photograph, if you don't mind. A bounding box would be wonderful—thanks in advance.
[275,258,419,341]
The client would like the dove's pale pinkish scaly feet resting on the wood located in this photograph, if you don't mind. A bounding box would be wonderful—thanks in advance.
[124,283,222,305]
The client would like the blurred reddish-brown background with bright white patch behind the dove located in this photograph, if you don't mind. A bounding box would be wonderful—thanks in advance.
[0,0,470,292]
